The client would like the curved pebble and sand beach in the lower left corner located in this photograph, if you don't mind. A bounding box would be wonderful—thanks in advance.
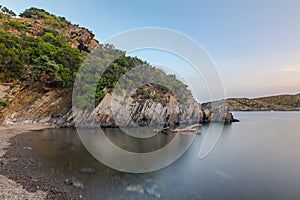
[0,124,84,200]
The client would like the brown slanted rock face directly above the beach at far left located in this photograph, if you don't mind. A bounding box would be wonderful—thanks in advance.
[0,86,71,125]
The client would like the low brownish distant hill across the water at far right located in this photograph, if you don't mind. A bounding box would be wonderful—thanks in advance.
[202,95,300,111]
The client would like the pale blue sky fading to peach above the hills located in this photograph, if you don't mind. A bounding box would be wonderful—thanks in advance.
[0,0,300,101]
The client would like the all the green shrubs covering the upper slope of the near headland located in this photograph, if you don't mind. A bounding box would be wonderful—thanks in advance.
[0,6,190,111]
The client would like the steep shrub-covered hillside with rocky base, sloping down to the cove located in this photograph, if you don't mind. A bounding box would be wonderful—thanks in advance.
[0,8,205,127]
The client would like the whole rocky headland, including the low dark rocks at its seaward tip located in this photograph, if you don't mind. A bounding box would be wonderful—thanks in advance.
[0,8,231,127]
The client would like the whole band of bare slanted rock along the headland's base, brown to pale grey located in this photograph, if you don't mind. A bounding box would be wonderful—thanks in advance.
[0,82,202,127]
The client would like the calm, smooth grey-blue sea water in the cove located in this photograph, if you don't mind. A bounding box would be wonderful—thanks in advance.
[28,112,300,200]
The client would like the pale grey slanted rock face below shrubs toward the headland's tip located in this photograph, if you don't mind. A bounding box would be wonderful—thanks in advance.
[71,85,202,127]
